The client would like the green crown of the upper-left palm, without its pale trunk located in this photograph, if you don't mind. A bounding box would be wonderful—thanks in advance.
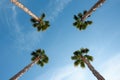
[31,13,50,31]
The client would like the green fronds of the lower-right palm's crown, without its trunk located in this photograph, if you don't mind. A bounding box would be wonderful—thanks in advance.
[71,48,93,68]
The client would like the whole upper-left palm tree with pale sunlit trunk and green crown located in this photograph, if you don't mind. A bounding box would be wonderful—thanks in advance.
[11,0,50,31]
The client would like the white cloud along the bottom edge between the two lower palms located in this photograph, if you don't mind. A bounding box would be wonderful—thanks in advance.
[35,66,86,80]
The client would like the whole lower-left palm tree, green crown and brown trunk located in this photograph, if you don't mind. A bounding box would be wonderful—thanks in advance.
[10,49,49,80]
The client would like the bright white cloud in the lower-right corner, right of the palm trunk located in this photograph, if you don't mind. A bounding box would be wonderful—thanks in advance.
[102,54,120,80]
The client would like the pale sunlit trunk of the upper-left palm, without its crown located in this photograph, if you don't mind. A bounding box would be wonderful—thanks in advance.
[11,0,39,21]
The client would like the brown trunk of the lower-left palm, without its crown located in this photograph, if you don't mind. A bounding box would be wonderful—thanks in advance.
[9,58,39,80]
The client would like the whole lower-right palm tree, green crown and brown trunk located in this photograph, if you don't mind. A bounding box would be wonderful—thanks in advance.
[71,48,105,80]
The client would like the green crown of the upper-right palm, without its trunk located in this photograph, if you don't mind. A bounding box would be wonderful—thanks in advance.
[73,10,92,30]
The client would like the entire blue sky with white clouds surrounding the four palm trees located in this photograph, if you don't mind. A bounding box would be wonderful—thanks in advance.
[0,0,120,80]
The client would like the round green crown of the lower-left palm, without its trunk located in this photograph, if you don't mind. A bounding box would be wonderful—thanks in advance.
[31,49,49,67]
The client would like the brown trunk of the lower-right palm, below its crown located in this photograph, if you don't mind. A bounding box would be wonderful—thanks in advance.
[83,58,105,80]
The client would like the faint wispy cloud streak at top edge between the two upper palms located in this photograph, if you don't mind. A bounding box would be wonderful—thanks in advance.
[49,0,72,21]
